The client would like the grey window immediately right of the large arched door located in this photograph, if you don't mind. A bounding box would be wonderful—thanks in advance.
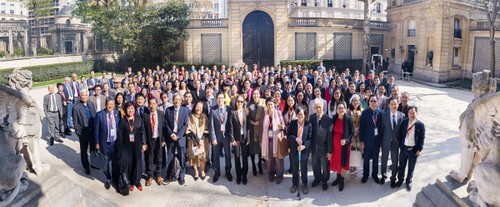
[295,32,316,60]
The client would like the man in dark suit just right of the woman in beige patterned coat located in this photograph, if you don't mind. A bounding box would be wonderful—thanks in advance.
[209,93,234,183]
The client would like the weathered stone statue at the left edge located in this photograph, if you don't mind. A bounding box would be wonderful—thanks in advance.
[0,68,50,206]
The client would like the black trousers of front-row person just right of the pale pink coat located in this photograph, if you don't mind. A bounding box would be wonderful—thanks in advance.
[289,148,308,186]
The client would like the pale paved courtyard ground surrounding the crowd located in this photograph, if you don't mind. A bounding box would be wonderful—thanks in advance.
[31,81,473,207]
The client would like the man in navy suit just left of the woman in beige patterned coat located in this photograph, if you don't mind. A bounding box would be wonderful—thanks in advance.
[162,94,189,185]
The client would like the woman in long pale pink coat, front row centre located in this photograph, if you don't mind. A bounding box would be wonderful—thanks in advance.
[261,97,288,184]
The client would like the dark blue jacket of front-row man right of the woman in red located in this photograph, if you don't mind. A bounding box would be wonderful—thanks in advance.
[359,108,383,148]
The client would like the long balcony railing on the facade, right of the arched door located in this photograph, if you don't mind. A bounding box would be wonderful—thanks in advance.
[288,18,391,30]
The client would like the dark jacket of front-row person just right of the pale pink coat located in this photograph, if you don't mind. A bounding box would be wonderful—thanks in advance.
[286,120,312,152]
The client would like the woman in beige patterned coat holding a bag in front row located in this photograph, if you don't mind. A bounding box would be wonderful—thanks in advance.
[186,102,210,181]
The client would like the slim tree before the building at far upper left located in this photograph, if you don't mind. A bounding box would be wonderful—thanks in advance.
[24,0,52,54]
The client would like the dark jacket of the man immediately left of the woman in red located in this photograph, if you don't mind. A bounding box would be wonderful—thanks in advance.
[309,113,333,153]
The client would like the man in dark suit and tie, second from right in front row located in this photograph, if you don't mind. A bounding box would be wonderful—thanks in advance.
[380,97,405,188]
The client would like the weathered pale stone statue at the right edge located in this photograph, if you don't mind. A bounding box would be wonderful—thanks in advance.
[450,71,500,206]
